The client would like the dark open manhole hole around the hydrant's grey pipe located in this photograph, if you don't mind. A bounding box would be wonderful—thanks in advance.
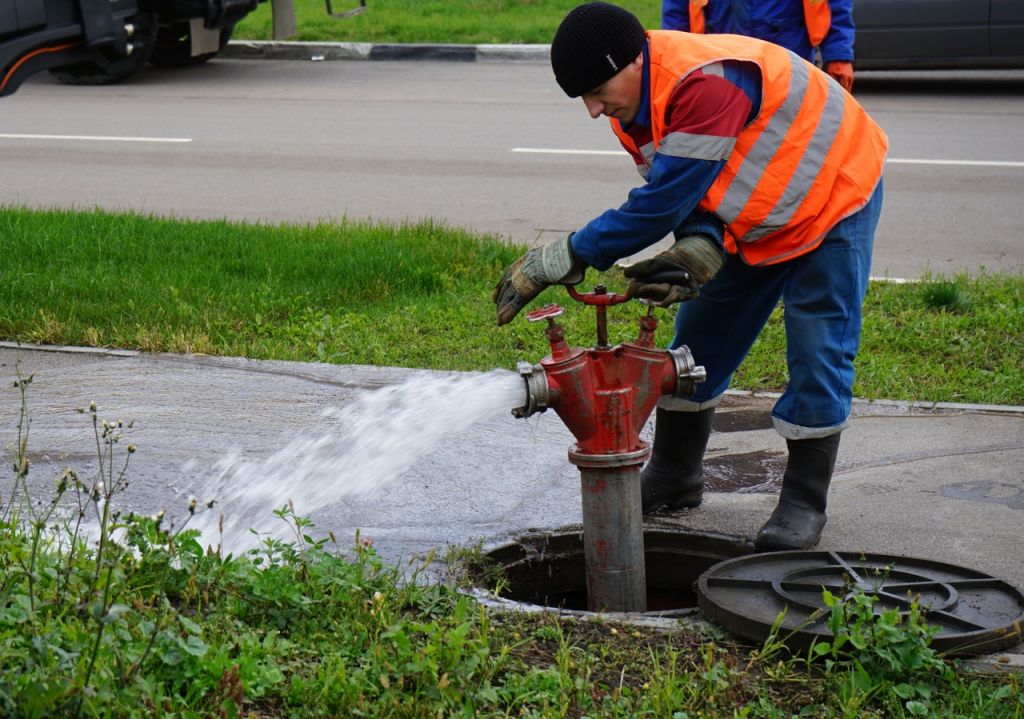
[479,528,754,617]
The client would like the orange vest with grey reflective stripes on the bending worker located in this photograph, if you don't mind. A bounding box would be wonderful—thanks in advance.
[611,30,889,265]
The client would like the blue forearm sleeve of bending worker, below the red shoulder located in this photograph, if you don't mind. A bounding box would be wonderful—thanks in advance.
[571,154,725,270]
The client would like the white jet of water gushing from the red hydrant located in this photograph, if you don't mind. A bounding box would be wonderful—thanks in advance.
[189,370,525,554]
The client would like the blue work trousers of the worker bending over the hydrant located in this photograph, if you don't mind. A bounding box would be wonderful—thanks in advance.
[659,180,883,439]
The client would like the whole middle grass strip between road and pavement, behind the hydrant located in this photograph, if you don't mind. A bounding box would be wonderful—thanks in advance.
[0,208,1024,405]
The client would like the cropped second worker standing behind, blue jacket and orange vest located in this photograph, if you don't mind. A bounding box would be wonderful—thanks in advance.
[662,0,854,92]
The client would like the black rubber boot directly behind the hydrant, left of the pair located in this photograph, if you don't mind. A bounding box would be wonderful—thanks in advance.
[640,408,715,514]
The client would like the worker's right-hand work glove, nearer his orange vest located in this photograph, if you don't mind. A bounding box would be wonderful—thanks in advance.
[623,235,725,307]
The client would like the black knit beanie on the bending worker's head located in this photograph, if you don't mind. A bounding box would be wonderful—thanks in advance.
[551,2,645,97]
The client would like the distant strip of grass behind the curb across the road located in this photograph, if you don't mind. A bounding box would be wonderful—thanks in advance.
[234,0,662,44]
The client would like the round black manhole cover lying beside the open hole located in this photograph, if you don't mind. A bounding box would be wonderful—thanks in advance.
[697,551,1024,655]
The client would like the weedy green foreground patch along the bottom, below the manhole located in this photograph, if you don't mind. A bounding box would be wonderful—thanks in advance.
[0,377,1024,719]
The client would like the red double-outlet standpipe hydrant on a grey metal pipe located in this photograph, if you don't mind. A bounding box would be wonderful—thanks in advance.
[512,286,707,611]
